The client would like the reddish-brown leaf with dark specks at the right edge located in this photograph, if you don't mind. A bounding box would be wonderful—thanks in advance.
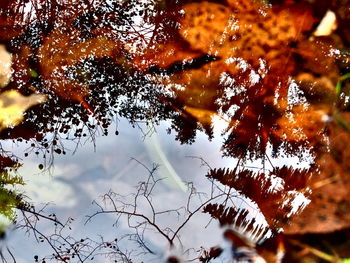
[284,114,350,234]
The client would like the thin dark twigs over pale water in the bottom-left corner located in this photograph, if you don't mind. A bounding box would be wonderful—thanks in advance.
[8,206,131,263]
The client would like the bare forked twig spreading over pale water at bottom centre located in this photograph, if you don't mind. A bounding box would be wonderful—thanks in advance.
[86,160,243,259]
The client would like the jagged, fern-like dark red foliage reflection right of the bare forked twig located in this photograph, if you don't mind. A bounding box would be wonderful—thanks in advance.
[204,166,311,232]
